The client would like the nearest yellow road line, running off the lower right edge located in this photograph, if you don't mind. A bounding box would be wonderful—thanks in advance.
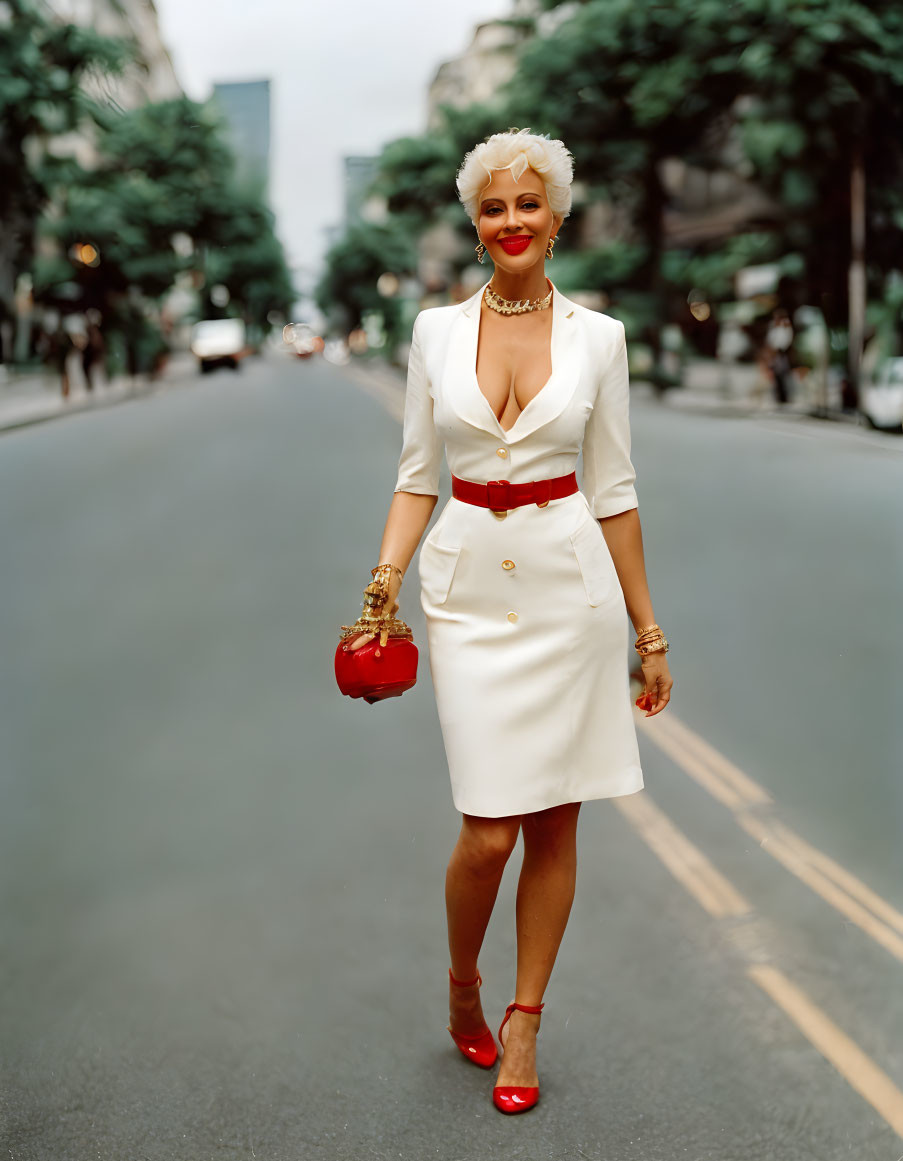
[746,964,903,1137]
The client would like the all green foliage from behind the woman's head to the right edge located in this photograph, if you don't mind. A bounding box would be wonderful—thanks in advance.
[315,0,903,345]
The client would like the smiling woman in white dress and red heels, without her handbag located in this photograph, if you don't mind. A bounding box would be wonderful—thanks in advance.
[338,129,672,1112]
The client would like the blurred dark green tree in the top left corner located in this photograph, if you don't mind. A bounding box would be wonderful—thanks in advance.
[0,0,128,359]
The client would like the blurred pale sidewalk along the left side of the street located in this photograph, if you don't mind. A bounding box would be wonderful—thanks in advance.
[0,351,197,432]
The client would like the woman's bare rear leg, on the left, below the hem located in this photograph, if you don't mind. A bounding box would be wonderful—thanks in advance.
[446,814,520,1036]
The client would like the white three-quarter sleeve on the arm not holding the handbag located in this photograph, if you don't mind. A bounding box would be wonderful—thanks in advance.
[583,322,638,519]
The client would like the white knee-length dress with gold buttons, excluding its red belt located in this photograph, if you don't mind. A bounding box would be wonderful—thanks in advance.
[395,279,643,817]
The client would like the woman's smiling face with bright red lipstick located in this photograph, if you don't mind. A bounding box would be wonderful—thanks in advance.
[477,170,561,274]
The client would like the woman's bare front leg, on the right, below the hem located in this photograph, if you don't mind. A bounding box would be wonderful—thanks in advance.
[497,802,580,1087]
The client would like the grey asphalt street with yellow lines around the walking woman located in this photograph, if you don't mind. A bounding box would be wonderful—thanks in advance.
[0,355,903,1161]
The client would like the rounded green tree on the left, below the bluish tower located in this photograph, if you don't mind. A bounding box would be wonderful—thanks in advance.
[36,98,295,345]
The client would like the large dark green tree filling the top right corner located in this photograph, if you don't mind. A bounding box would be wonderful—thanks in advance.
[507,0,903,390]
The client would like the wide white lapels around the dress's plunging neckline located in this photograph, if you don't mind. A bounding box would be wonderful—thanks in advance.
[442,282,580,444]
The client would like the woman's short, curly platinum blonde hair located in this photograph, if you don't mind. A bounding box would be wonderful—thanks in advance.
[455,129,573,225]
